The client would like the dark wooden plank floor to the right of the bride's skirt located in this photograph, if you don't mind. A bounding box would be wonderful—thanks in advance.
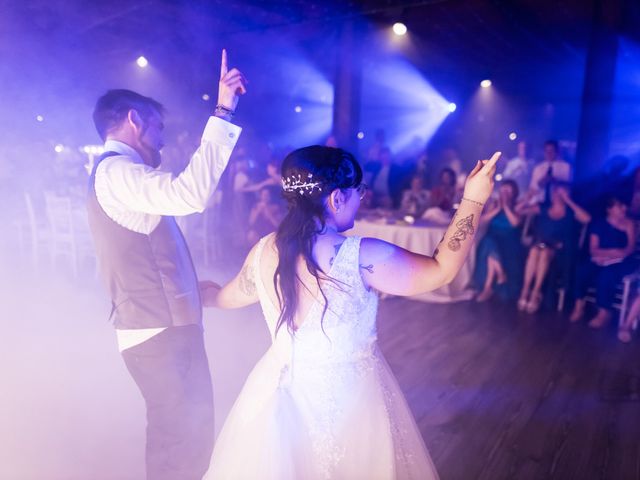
[379,298,640,480]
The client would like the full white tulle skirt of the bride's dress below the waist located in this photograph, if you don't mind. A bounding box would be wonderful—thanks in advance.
[204,349,438,480]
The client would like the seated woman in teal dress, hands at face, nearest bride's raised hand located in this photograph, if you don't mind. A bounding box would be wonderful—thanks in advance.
[473,180,524,302]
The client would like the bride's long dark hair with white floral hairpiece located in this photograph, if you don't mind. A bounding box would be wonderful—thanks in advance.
[273,145,362,332]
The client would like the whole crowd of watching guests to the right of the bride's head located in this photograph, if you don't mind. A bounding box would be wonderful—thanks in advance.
[352,135,640,342]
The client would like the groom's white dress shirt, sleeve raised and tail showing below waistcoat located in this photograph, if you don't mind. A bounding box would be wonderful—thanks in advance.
[95,117,242,351]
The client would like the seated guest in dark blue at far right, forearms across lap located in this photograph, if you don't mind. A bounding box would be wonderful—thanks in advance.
[569,197,637,328]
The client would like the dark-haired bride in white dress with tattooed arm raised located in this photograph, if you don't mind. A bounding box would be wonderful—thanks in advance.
[201,146,500,480]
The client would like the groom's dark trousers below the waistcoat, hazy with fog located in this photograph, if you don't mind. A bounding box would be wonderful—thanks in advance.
[122,325,214,480]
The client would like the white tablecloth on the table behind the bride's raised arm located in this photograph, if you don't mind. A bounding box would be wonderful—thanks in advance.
[347,220,475,303]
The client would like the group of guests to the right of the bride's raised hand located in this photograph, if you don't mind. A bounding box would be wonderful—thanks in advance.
[474,141,640,342]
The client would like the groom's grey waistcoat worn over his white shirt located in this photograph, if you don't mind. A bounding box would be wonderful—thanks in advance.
[87,152,202,329]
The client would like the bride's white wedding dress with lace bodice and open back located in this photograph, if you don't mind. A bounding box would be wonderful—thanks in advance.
[204,237,438,480]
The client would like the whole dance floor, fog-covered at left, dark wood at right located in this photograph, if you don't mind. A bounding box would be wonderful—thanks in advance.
[0,258,640,480]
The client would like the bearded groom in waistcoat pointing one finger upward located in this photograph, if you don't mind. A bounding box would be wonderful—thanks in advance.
[87,50,246,480]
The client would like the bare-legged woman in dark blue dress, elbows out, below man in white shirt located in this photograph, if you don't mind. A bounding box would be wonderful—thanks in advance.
[518,182,591,313]
